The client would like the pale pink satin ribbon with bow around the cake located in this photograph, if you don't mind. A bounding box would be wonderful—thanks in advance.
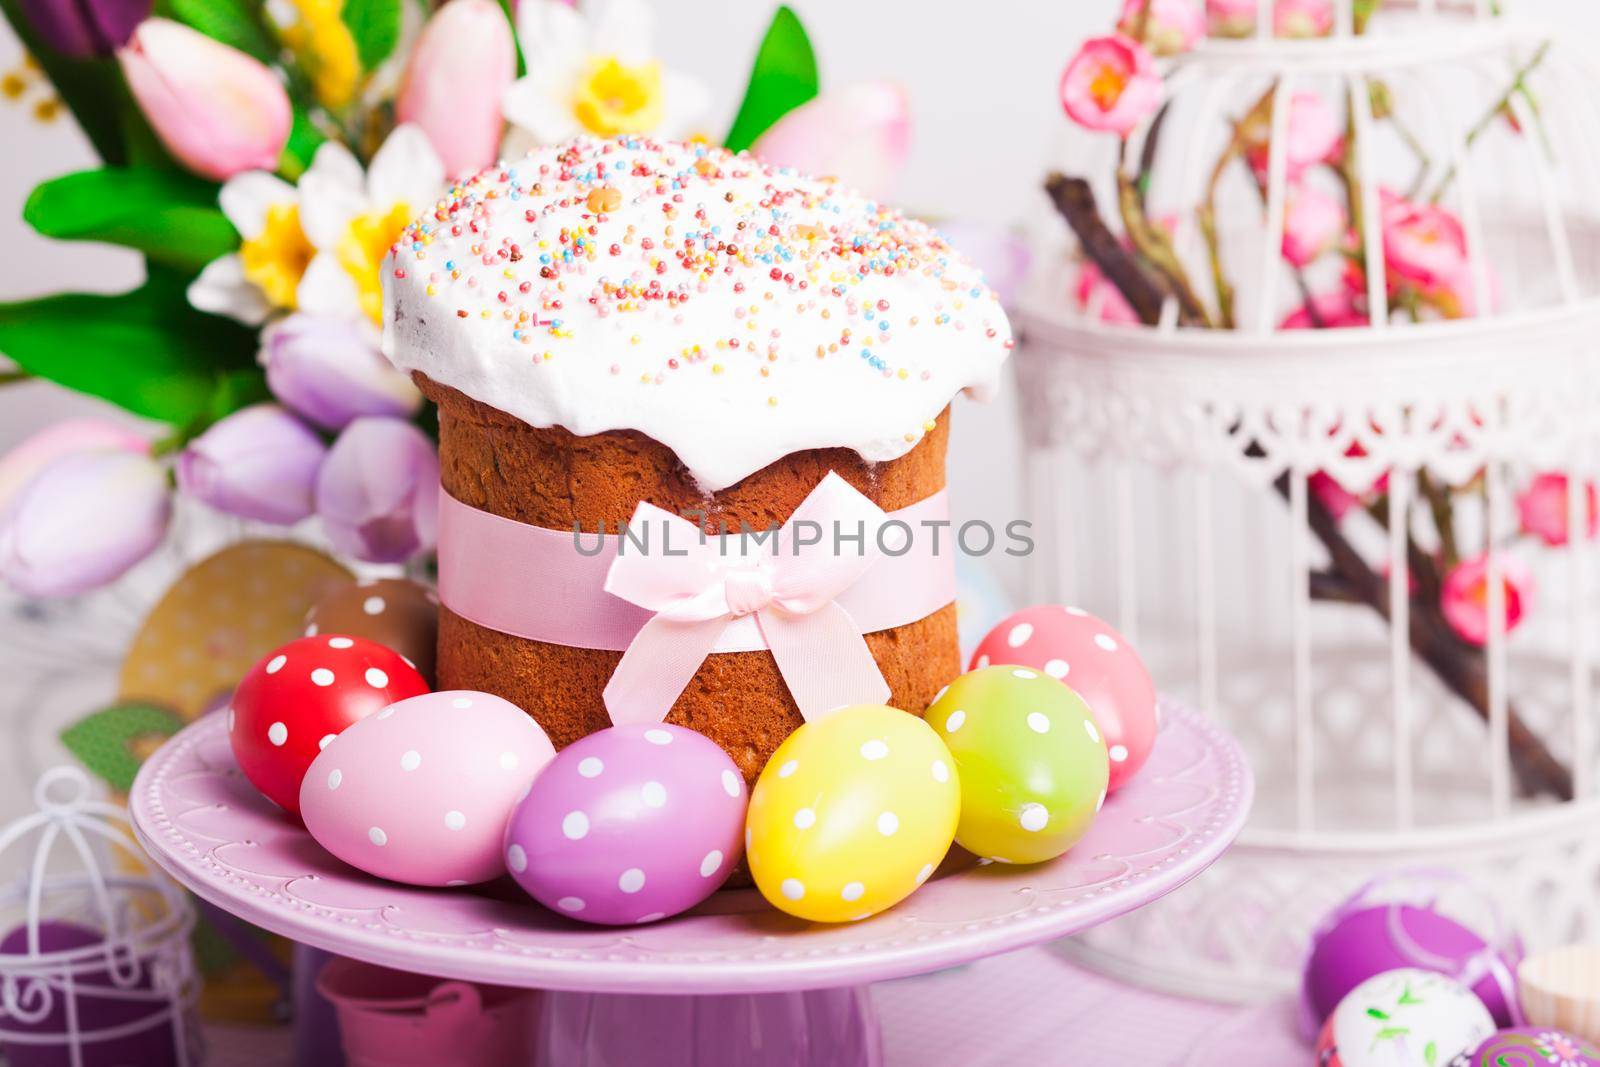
[438,474,955,723]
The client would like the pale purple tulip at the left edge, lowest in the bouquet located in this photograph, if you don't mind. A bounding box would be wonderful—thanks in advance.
[0,448,173,597]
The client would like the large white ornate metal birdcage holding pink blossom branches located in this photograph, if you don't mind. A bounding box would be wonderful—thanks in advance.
[1016,0,1600,998]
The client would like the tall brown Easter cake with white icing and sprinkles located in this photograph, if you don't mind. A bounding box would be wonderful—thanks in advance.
[384,138,1011,781]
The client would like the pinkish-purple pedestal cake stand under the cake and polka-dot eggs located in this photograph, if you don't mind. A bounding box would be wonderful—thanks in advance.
[130,702,1253,1067]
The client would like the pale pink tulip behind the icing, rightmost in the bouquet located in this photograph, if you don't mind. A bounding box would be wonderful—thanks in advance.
[750,82,910,198]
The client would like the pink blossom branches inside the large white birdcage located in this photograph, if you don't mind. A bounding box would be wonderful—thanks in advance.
[1046,0,1580,798]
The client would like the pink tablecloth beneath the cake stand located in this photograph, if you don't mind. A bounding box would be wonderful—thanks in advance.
[208,949,1312,1067]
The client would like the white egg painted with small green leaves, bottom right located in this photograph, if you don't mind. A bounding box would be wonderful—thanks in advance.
[1317,968,1494,1067]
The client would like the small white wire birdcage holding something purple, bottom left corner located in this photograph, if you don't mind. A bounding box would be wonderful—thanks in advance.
[0,766,200,1067]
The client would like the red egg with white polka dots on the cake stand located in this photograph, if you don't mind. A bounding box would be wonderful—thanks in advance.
[226,633,427,814]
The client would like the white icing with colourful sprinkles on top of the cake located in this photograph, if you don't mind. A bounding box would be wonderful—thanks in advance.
[384,138,1011,490]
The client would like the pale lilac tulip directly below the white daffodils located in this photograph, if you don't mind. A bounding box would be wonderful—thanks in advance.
[261,315,419,430]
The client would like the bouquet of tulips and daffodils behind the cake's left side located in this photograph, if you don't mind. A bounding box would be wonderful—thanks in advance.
[0,0,909,597]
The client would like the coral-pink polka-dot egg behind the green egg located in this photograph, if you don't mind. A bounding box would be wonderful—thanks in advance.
[973,605,1160,792]
